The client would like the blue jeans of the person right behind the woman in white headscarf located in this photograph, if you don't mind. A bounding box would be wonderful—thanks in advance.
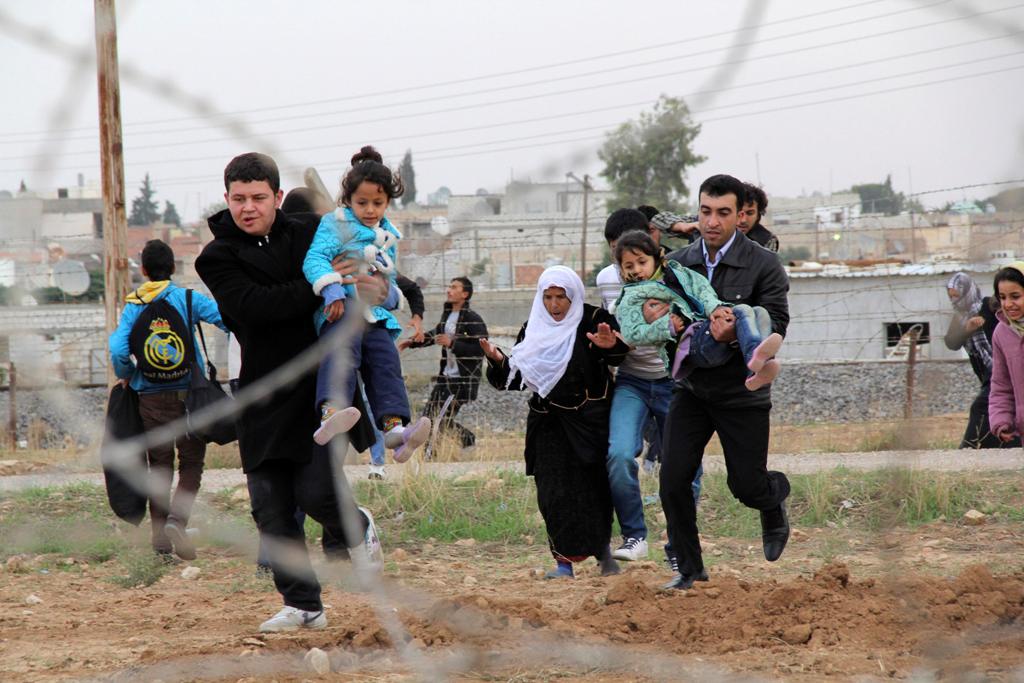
[606,373,700,539]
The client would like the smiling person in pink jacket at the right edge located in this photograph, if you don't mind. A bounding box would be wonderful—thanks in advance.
[988,261,1024,441]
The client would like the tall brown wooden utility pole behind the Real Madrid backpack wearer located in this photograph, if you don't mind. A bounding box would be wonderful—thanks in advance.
[93,0,129,384]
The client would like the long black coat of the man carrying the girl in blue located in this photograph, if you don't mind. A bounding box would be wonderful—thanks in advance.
[196,209,370,472]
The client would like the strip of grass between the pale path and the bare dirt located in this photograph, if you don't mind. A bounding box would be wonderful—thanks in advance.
[6,469,1024,565]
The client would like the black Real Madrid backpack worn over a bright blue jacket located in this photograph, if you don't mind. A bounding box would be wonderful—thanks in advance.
[128,290,196,383]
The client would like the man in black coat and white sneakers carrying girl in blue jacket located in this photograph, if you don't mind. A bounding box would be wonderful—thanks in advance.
[196,154,379,632]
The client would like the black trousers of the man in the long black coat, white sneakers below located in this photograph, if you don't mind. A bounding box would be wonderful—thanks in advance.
[246,445,367,611]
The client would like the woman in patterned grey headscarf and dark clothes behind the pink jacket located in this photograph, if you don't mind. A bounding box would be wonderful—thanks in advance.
[945,272,1020,449]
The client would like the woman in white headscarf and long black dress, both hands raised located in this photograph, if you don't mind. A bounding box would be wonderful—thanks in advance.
[480,265,629,579]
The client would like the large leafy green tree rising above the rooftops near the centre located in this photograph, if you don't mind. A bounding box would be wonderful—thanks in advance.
[597,95,705,211]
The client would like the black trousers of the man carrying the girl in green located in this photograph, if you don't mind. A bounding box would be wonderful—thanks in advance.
[659,387,790,574]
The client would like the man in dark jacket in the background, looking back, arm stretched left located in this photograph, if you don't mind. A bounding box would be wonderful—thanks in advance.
[398,278,487,449]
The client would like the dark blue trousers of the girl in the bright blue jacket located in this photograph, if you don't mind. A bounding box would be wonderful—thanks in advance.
[316,315,411,428]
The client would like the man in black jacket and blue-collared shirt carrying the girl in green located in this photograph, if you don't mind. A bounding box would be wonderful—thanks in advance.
[659,175,790,589]
